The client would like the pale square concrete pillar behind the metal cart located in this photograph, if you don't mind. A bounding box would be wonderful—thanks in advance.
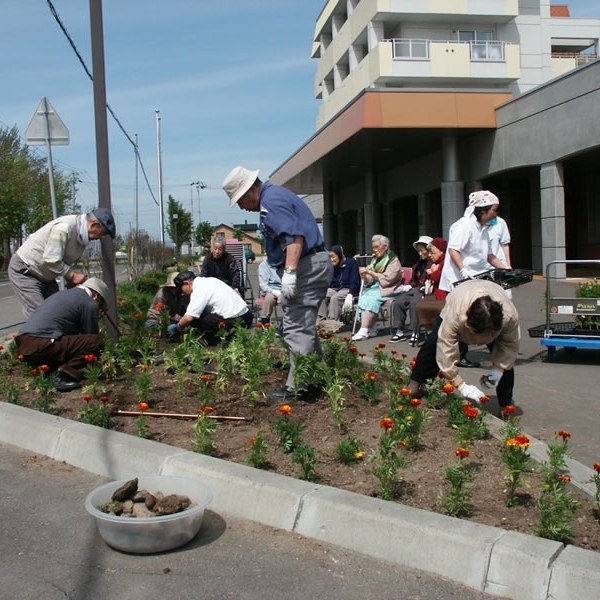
[540,162,567,277]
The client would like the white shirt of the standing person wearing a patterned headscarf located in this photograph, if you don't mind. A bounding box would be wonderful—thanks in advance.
[440,215,493,292]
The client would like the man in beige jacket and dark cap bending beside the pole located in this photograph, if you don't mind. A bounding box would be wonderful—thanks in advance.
[8,208,116,317]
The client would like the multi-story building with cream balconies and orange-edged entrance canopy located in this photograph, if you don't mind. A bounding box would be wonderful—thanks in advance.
[271,0,600,269]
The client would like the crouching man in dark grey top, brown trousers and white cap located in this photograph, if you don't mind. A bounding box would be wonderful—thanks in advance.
[15,277,108,392]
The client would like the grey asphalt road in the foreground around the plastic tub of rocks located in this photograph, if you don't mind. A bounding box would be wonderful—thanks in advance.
[0,444,498,600]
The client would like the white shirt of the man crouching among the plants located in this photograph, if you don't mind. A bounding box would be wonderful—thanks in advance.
[185,277,248,319]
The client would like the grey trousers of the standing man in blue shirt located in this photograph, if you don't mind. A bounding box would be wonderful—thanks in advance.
[281,251,333,388]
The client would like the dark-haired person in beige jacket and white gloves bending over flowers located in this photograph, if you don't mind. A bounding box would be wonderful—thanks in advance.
[408,279,520,410]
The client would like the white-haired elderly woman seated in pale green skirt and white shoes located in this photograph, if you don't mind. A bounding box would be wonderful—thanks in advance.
[352,234,402,342]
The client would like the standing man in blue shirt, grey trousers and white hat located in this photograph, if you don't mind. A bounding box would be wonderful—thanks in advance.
[223,167,333,401]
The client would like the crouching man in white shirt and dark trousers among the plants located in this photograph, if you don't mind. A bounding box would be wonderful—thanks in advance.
[169,271,252,345]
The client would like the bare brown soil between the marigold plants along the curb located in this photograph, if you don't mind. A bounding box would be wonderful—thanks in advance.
[4,350,600,551]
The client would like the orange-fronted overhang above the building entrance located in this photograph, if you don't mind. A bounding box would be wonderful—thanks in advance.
[270,90,512,194]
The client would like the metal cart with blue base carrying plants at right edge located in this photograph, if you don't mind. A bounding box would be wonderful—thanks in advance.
[529,260,600,362]
